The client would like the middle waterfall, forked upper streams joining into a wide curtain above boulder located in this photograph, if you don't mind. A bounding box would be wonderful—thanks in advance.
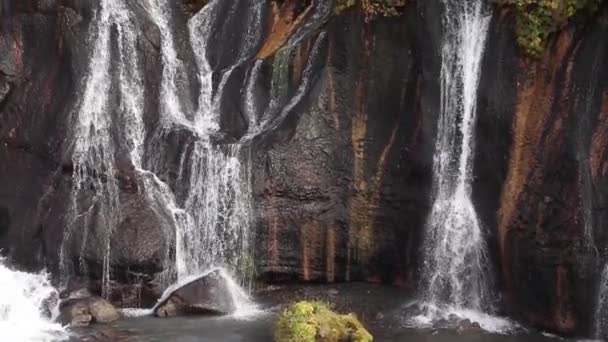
[149,1,260,304]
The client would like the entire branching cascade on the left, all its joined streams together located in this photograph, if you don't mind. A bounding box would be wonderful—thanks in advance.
[55,0,255,304]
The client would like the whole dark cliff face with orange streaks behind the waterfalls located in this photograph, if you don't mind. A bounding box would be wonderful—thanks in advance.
[0,0,608,333]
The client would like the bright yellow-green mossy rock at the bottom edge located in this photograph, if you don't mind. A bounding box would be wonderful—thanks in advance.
[275,301,373,342]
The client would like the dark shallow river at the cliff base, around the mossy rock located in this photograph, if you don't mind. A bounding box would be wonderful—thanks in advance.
[73,284,592,342]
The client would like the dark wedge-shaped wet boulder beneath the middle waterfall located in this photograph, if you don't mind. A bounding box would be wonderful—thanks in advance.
[153,269,236,317]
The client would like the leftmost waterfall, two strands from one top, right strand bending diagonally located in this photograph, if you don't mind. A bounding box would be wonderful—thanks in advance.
[60,0,186,298]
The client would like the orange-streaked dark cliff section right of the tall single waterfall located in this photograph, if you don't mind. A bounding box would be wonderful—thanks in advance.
[497,6,608,332]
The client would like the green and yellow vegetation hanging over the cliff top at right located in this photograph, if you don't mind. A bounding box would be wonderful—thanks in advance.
[498,0,603,57]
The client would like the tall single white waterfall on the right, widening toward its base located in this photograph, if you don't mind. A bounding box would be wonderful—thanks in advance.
[421,0,502,327]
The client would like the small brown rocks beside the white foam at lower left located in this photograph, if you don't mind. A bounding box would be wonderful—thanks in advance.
[59,297,120,327]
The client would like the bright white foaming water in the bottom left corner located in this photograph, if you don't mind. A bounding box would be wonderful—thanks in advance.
[0,259,68,342]
